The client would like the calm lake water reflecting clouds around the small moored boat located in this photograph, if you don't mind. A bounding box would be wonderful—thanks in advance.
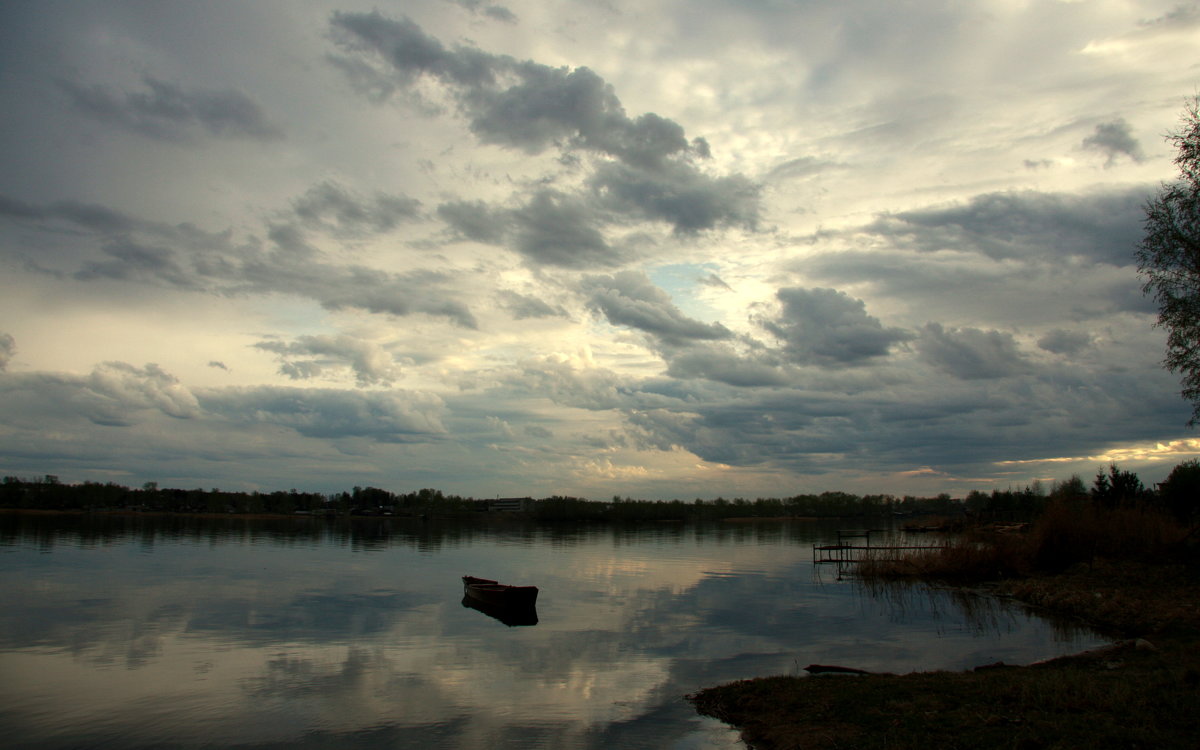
[0,515,1099,750]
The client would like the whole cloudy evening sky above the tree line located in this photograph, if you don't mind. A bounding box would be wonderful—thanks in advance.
[0,0,1200,499]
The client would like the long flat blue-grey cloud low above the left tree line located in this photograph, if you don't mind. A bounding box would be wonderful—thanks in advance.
[197,386,445,443]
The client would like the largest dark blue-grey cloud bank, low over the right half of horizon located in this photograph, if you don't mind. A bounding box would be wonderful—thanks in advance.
[492,326,1186,479]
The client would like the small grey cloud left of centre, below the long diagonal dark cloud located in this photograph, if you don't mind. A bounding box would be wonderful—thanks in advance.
[292,181,421,236]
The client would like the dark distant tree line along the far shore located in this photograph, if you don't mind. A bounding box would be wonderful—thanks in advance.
[0,460,1200,522]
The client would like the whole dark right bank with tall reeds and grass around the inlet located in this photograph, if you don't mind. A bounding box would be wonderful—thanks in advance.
[689,506,1200,750]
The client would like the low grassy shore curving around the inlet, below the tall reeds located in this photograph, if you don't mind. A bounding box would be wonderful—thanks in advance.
[686,562,1200,750]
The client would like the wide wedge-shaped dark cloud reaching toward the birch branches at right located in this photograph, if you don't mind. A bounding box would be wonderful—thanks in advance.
[863,188,1153,266]
